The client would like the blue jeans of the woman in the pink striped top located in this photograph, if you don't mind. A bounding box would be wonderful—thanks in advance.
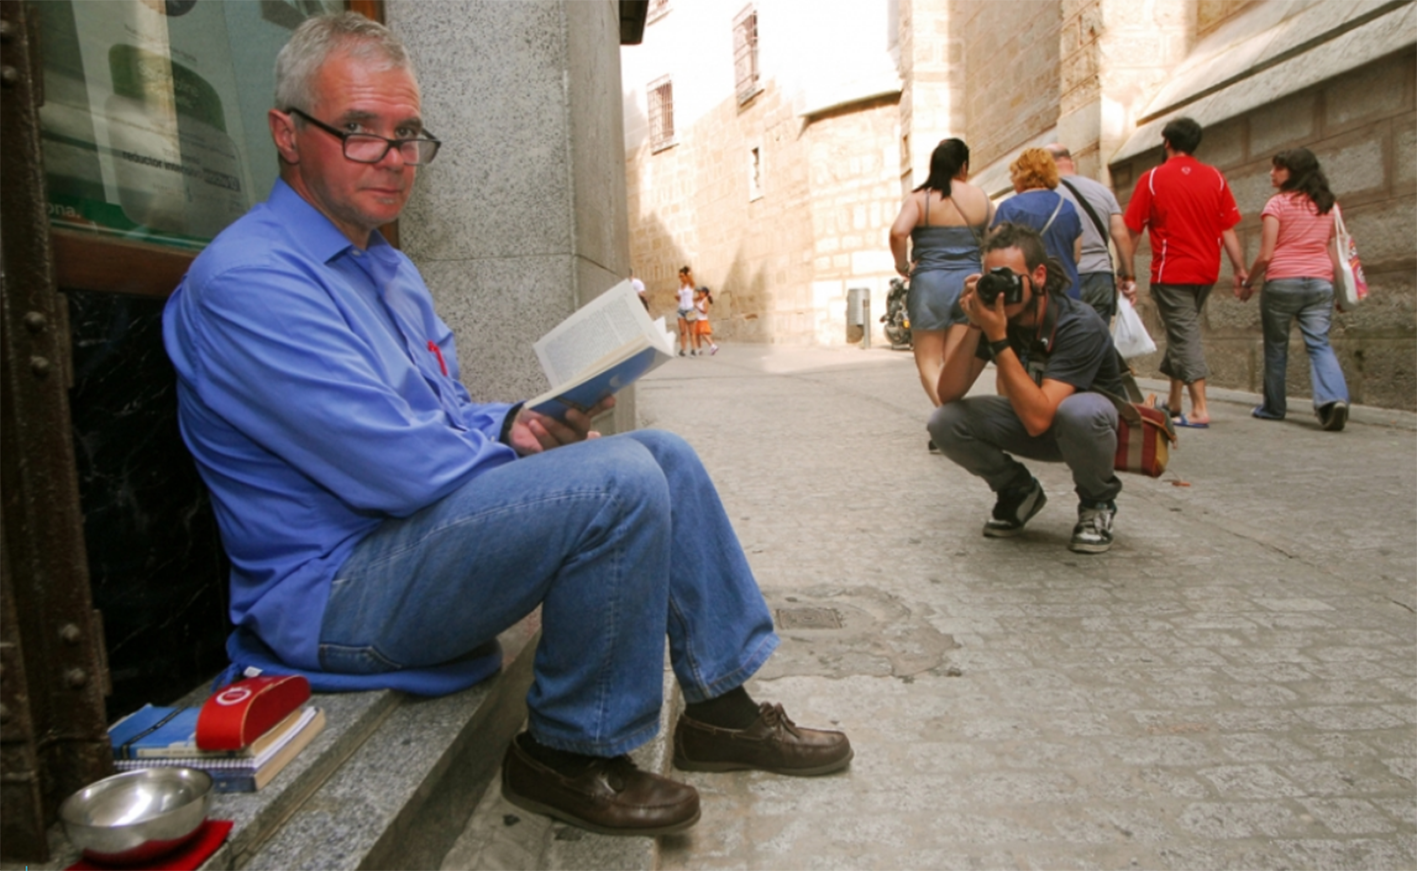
[1258,278,1348,418]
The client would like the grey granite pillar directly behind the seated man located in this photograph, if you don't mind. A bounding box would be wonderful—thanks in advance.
[385,0,633,429]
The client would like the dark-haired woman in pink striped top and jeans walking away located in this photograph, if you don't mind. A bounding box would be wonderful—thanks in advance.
[1236,149,1348,432]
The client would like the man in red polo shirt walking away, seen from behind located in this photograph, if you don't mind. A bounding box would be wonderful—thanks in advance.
[1124,118,1247,428]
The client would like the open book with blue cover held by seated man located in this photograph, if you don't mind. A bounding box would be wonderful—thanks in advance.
[527,282,674,418]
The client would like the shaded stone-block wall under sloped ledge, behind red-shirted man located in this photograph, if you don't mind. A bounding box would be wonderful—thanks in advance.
[1111,52,1417,409]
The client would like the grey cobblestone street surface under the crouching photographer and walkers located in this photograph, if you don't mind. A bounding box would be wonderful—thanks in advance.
[639,346,1417,871]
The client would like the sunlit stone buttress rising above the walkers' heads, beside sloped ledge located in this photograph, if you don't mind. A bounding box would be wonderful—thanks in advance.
[1058,0,1196,183]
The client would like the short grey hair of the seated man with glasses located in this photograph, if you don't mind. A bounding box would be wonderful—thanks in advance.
[275,13,414,112]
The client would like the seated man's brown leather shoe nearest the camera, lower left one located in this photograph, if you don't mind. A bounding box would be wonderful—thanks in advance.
[502,738,699,836]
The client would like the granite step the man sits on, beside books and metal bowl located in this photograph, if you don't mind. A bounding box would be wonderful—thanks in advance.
[0,617,536,871]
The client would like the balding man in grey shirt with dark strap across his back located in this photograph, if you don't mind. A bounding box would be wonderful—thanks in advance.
[1044,142,1136,323]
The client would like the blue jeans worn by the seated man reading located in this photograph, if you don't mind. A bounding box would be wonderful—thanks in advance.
[320,431,778,756]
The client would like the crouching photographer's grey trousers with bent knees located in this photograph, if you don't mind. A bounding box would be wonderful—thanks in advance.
[930,392,1122,503]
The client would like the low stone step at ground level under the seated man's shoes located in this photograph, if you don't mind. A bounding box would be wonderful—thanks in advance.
[441,668,682,871]
